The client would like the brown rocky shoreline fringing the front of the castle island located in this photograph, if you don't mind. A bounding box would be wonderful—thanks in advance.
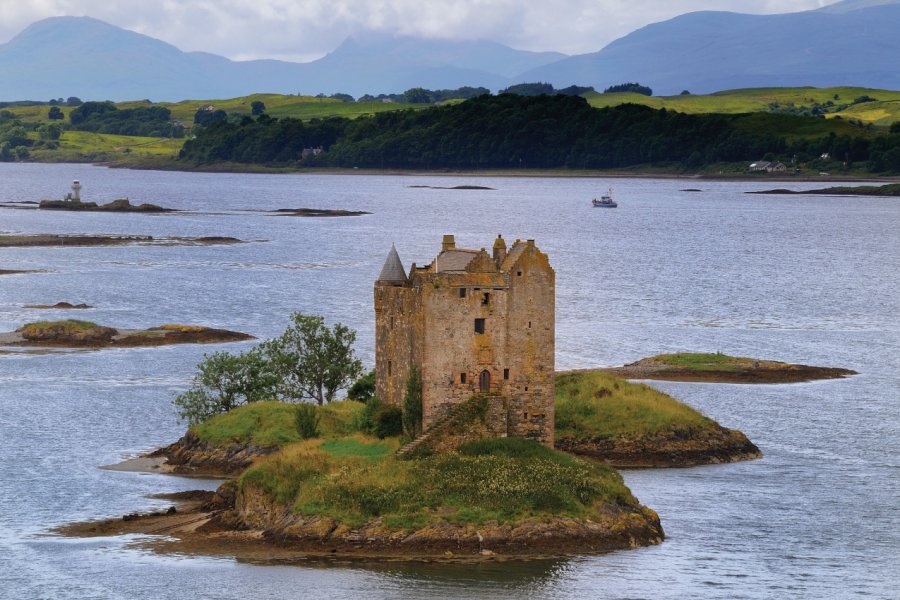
[54,484,664,560]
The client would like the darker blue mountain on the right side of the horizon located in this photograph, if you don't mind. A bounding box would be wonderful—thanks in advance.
[519,0,900,95]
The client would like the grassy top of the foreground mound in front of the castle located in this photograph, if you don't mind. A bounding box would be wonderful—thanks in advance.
[238,435,638,530]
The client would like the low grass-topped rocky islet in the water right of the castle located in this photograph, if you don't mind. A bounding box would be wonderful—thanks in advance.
[589,352,857,383]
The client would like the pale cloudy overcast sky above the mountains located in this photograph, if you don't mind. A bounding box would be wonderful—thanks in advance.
[0,0,836,61]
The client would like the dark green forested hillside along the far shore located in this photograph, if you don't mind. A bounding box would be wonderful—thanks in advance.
[180,94,900,172]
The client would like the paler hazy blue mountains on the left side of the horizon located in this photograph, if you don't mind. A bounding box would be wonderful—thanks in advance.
[0,17,565,101]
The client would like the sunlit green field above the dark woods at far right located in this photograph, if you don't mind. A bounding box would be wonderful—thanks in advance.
[585,87,900,127]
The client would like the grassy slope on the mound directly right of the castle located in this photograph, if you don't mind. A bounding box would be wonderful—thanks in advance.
[556,372,716,440]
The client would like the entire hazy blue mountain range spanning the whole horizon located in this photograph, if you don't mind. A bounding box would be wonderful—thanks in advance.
[0,0,900,101]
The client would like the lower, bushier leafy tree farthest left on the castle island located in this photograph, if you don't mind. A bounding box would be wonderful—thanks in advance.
[172,348,277,425]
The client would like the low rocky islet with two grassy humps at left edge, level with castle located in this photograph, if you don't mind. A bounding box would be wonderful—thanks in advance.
[0,319,255,349]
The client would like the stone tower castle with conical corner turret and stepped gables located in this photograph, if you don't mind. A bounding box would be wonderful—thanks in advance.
[375,235,556,446]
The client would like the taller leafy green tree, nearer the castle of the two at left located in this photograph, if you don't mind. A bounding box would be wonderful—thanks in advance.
[261,313,363,405]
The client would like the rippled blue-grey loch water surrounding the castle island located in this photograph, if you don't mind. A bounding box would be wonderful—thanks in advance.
[0,164,900,600]
